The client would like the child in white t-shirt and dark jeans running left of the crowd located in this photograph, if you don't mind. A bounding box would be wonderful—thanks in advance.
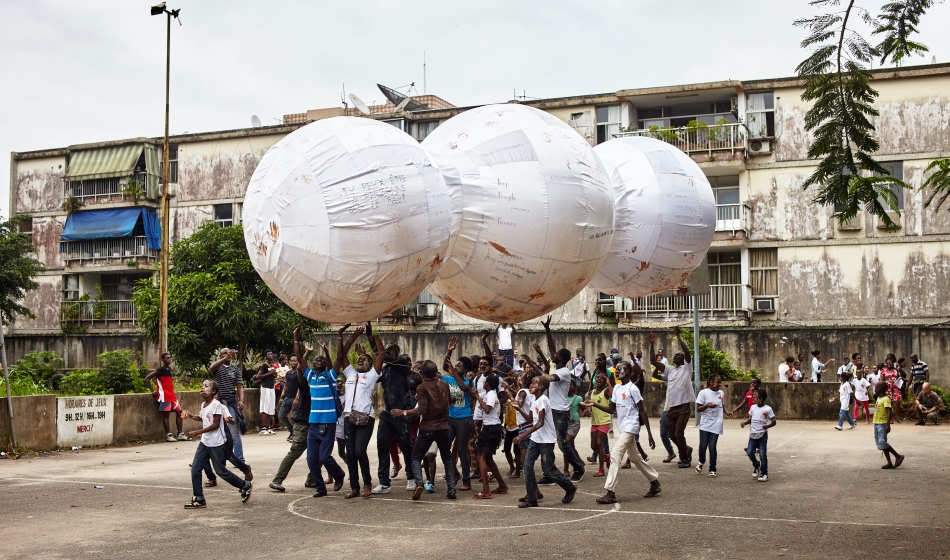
[181,379,251,509]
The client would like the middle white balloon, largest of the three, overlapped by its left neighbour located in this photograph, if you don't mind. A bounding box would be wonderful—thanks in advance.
[423,104,613,323]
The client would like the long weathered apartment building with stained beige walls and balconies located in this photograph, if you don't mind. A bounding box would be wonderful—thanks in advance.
[8,64,950,385]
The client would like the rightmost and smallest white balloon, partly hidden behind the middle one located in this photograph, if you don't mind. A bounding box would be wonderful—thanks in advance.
[590,137,716,298]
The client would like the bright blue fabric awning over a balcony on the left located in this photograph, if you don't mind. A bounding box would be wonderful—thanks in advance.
[63,208,162,249]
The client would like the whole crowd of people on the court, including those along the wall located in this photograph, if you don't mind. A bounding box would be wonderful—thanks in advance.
[143,318,942,508]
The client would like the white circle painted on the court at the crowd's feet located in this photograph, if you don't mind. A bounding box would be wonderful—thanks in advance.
[287,492,620,531]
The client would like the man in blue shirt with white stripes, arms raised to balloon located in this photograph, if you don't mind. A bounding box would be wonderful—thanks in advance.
[294,325,346,498]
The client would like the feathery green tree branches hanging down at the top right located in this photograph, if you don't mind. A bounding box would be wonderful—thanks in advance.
[795,0,950,226]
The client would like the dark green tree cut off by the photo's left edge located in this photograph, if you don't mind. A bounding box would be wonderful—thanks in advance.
[0,215,46,323]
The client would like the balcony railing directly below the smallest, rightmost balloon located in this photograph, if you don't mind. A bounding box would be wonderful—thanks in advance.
[601,284,750,319]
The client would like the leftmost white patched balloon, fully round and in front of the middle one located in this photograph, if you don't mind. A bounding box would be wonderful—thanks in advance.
[243,117,451,323]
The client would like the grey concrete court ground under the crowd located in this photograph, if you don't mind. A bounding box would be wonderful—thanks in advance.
[0,419,950,560]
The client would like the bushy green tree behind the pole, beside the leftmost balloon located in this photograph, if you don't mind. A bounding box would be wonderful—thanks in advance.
[133,222,326,371]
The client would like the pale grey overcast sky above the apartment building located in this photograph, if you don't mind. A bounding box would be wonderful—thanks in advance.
[0,0,950,217]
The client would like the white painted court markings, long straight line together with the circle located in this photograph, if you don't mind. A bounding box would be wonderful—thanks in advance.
[0,476,950,531]
